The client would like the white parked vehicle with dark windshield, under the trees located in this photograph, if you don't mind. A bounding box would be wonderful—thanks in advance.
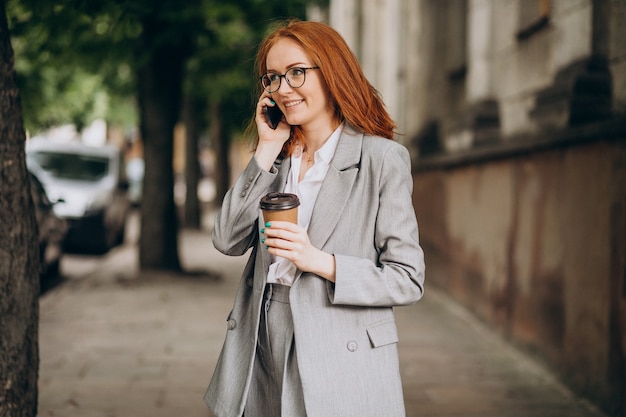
[26,138,130,254]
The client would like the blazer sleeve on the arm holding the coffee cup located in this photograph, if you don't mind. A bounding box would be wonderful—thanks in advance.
[330,143,425,306]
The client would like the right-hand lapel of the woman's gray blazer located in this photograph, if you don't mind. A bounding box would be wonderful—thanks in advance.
[308,124,363,248]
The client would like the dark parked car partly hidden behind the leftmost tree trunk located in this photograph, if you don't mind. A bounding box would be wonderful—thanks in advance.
[29,169,68,278]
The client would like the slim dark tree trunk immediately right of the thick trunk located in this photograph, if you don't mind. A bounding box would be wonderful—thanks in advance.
[183,94,200,229]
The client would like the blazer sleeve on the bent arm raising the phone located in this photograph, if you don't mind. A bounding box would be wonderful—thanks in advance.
[212,157,278,256]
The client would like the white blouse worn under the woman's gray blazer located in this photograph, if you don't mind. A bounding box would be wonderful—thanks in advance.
[267,124,343,286]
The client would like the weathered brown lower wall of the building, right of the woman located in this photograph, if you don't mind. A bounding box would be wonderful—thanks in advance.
[414,141,626,410]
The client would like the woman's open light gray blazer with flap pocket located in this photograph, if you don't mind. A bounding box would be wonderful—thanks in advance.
[204,125,424,417]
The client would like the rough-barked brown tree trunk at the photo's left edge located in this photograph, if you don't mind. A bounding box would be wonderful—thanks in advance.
[0,0,39,417]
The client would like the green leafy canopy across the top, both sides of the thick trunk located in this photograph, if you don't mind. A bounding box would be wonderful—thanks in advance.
[6,0,307,132]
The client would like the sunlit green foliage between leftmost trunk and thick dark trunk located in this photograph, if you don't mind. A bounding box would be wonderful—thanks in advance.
[7,0,140,132]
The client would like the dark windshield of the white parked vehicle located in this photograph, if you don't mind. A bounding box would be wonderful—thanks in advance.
[29,151,109,181]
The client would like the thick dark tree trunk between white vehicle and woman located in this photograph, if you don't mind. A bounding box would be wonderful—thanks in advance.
[137,14,185,270]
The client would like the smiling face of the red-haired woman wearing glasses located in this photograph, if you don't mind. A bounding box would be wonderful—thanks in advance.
[266,39,335,132]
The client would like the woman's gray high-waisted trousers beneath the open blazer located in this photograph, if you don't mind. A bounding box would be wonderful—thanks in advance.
[244,284,306,417]
